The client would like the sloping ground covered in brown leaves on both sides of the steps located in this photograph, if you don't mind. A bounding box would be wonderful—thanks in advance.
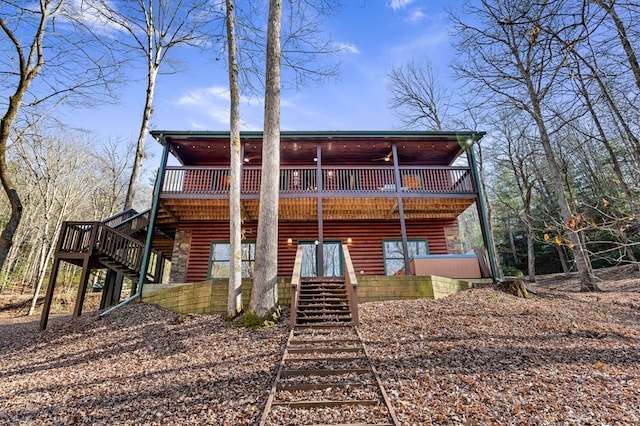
[0,267,640,425]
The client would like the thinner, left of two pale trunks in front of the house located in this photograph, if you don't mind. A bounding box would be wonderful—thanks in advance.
[226,0,242,317]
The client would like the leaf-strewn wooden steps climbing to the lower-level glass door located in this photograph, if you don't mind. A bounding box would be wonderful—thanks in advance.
[260,247,398,426]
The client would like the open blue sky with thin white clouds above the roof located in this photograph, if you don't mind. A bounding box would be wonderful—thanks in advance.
[73,0,458,161]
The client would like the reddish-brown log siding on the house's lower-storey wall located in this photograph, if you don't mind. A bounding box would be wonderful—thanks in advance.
[179,220,456,282]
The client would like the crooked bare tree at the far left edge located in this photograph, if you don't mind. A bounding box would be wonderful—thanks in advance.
[0,0,116,268]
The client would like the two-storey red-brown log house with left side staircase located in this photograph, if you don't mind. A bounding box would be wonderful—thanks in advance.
[43,131,495,326]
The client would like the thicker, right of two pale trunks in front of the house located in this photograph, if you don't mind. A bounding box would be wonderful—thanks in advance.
[250,0,282,318]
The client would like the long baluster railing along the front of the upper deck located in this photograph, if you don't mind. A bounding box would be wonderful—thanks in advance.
[162,166,476,195]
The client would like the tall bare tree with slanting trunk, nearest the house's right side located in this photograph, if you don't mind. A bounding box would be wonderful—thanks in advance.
[453,0,598,291]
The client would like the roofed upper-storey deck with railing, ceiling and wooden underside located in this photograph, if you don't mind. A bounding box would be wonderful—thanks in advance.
[153,132,482,233]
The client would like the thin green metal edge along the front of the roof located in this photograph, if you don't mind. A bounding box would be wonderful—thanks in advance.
[150,130,486,143]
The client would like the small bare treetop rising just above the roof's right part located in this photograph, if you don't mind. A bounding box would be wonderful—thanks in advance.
[388,60,451,130]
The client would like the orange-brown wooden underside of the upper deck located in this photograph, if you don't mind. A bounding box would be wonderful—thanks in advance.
[158,197,475,225]
